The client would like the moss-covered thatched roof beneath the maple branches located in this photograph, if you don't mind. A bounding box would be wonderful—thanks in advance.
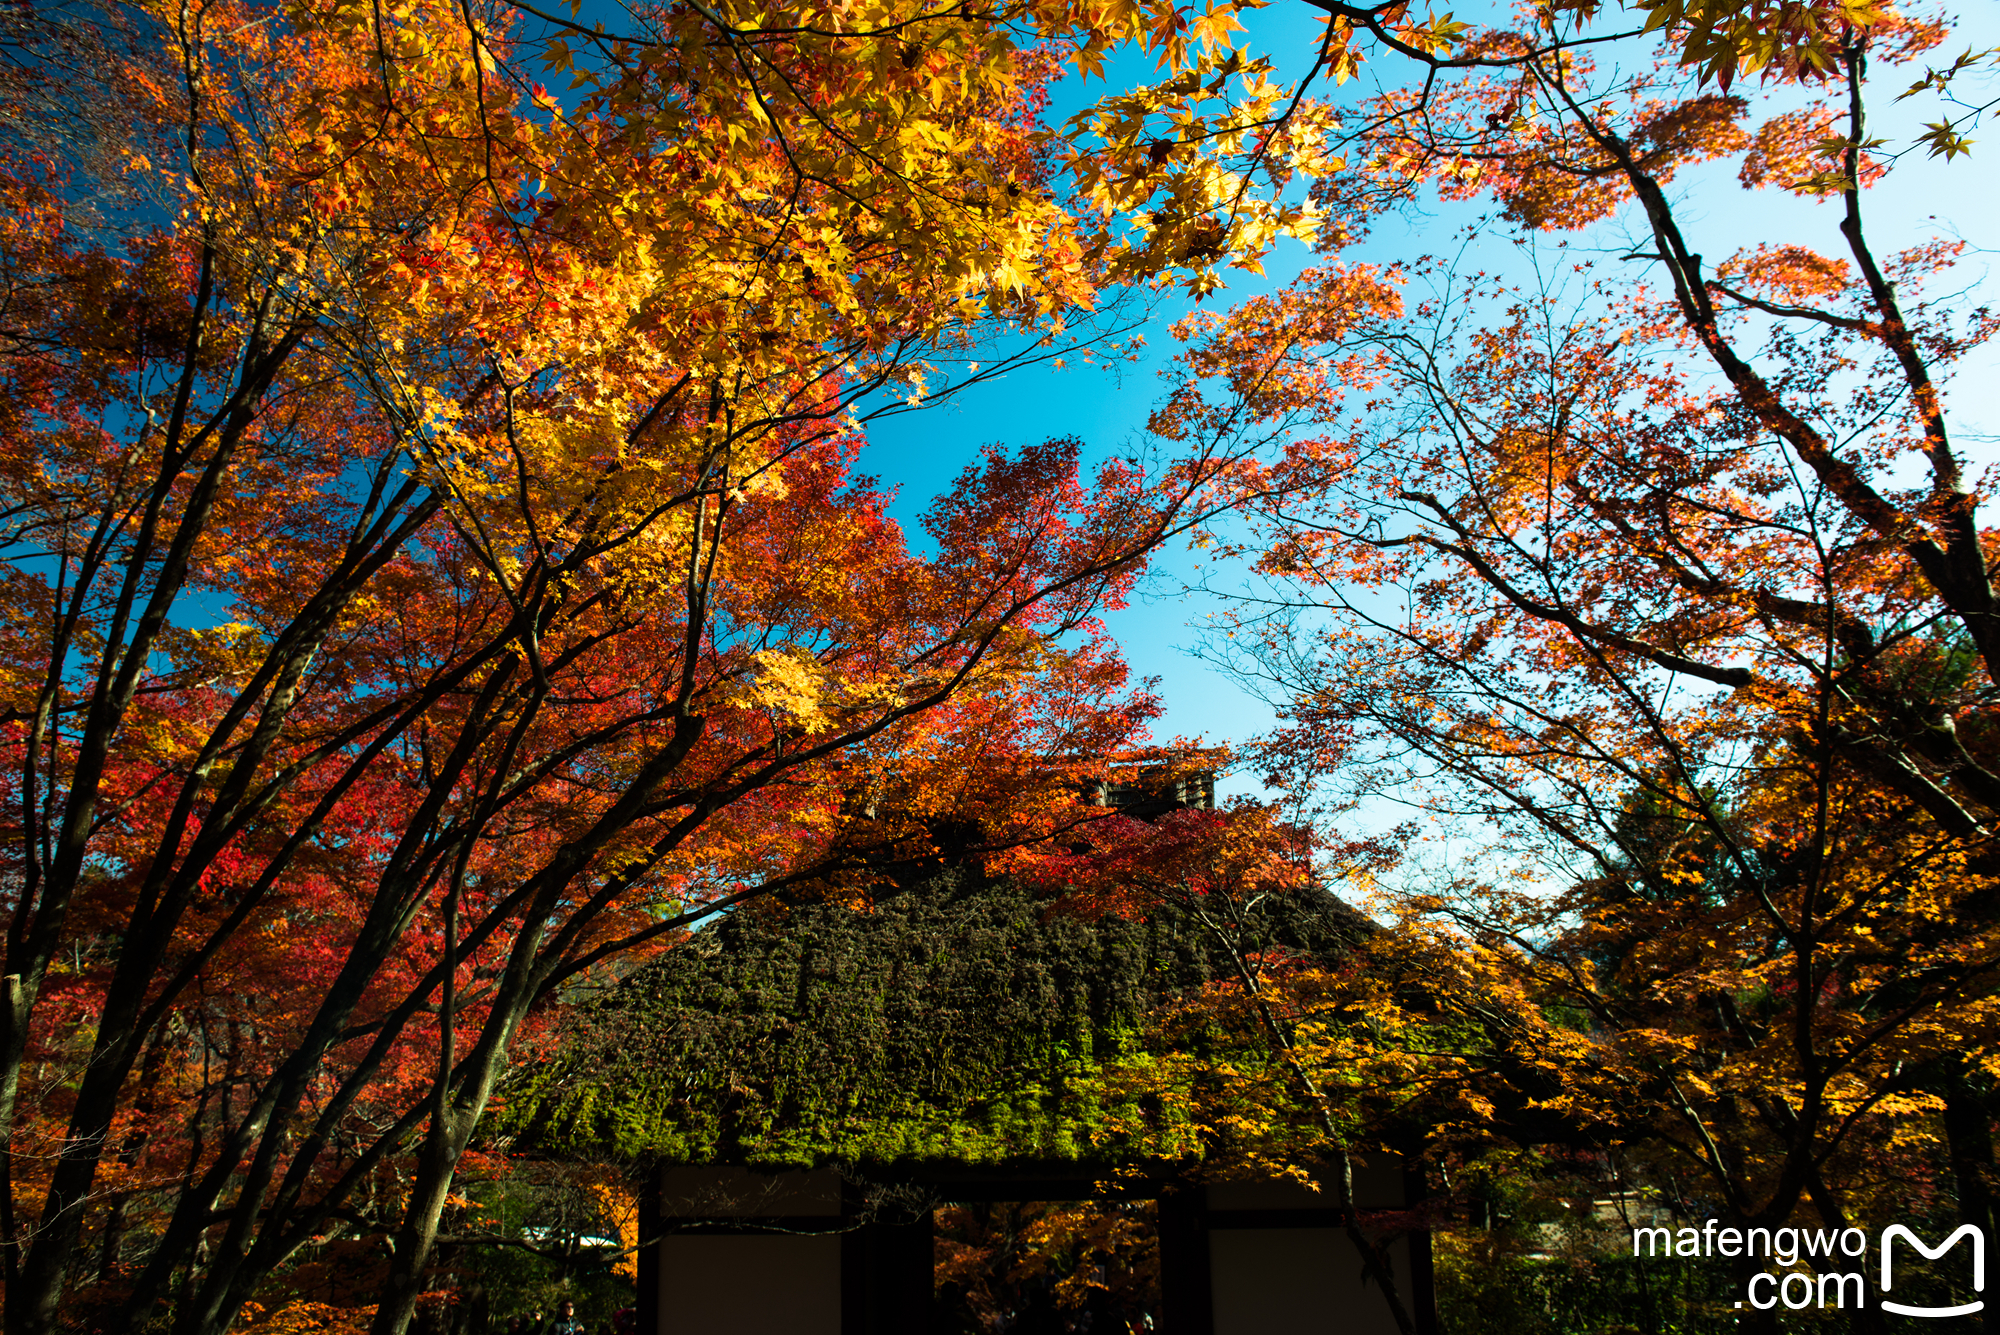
[498,873,1362,1167]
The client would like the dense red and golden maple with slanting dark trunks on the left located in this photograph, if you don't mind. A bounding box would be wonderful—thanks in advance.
[0,0,1344,1335]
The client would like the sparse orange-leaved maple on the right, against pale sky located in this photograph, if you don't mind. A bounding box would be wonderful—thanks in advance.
[1156,4,2000,1303]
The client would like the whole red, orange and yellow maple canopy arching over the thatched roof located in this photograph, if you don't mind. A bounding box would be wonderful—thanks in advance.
[0,0,2000,1335]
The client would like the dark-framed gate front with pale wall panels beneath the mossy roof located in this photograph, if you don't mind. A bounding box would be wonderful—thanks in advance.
[640,1165,1434,1335]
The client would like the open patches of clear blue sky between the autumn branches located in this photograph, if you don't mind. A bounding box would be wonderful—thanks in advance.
[862,2,2000,793]
